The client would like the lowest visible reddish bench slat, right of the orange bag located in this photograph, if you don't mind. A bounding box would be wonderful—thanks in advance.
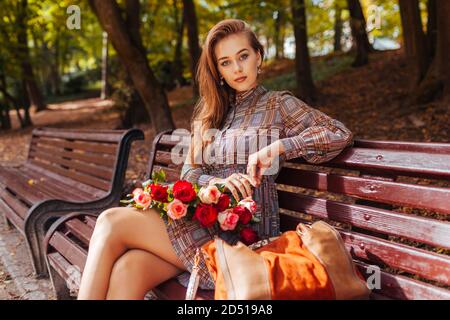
[355,261,450,300]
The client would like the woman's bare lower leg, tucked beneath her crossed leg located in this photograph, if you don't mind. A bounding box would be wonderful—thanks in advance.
[106,249,181,300]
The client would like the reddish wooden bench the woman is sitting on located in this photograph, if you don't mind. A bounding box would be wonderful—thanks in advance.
[45,132,450,299]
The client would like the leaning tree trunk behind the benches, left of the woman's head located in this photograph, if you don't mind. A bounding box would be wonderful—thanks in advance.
[89,0,174,132]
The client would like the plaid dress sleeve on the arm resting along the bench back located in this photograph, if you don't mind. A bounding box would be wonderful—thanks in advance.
[278,92,353,163]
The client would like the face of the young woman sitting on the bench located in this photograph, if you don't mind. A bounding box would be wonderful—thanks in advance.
[214,33,261,91]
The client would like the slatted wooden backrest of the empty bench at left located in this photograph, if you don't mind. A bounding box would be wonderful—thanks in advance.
[27,128,143,196]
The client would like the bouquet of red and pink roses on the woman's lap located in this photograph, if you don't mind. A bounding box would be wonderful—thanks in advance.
[121,170,259,245]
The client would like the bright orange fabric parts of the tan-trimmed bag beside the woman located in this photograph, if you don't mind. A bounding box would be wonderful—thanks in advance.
[203,231,335,300]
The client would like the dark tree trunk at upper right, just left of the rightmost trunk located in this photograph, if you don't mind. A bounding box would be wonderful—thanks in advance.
[399,0,429,87]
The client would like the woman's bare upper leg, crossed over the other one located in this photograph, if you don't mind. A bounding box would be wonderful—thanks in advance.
[78,208,185,299]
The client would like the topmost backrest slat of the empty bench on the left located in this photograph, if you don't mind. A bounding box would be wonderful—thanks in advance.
[33,129,123,142]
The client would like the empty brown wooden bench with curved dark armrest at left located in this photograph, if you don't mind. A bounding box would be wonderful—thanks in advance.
[0,128,144,276]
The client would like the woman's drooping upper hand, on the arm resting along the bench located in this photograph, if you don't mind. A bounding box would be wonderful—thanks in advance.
[247,140,284,187]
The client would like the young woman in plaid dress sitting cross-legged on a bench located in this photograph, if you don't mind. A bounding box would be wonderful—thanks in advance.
[78,19,352,299]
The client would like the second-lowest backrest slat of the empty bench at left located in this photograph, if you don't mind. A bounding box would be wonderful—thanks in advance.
[30,150,113,181]
